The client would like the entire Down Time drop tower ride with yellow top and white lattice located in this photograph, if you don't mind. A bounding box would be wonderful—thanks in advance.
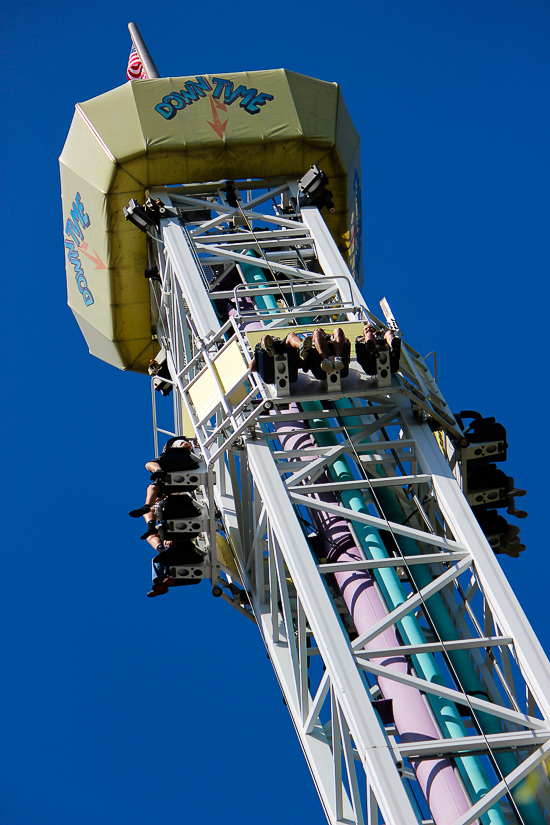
[60,24,550,825]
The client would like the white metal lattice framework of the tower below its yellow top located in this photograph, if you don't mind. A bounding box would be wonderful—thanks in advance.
[143,180,550,825]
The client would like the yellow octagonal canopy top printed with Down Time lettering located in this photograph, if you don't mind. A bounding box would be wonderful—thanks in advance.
[60,69,362,372]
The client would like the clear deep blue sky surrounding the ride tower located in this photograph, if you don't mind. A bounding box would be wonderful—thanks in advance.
[0,0,550,825]
